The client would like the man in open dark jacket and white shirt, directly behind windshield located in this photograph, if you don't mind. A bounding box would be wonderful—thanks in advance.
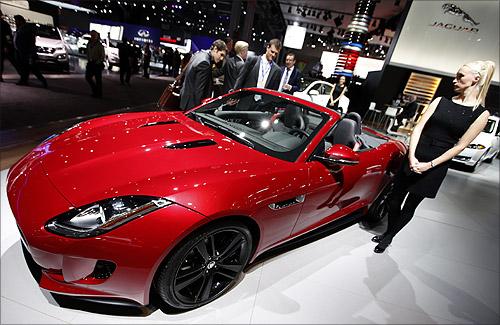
[234,38,281,90]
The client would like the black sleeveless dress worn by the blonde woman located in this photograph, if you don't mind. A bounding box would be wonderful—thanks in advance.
[394,98,486,198]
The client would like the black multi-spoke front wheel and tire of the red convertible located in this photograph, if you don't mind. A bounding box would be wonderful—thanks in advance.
[154,221,252,310]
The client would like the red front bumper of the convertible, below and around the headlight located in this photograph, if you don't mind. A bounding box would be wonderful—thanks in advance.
[7,155,207,305]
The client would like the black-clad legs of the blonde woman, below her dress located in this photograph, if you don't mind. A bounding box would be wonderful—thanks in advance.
[382,186,425,244]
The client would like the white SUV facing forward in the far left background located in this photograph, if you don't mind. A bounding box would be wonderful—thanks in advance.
[35,24,69,71]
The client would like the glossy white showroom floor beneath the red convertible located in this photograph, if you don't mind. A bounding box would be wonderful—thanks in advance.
[1,159,500,324]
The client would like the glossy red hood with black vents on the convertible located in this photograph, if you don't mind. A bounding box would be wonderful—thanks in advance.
[38,112,290,210]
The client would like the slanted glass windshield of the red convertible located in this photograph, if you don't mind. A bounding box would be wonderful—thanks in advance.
[188,91,329,161]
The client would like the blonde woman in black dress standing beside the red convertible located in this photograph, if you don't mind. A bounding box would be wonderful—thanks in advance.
[372,61,495,253]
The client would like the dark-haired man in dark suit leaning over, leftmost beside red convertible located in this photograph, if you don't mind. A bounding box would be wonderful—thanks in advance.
[180,40,227,111]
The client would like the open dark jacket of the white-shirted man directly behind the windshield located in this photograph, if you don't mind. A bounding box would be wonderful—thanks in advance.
[234,55,281,90]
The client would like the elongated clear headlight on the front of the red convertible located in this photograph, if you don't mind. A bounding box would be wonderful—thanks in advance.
[45,196,172,238]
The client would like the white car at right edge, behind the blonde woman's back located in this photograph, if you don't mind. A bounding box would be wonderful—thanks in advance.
[453,116,500,171]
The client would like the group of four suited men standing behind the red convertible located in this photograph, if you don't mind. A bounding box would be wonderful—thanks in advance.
[180,39,302,110]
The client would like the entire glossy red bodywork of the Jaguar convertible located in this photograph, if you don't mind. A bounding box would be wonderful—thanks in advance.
[7,90,405,304]
